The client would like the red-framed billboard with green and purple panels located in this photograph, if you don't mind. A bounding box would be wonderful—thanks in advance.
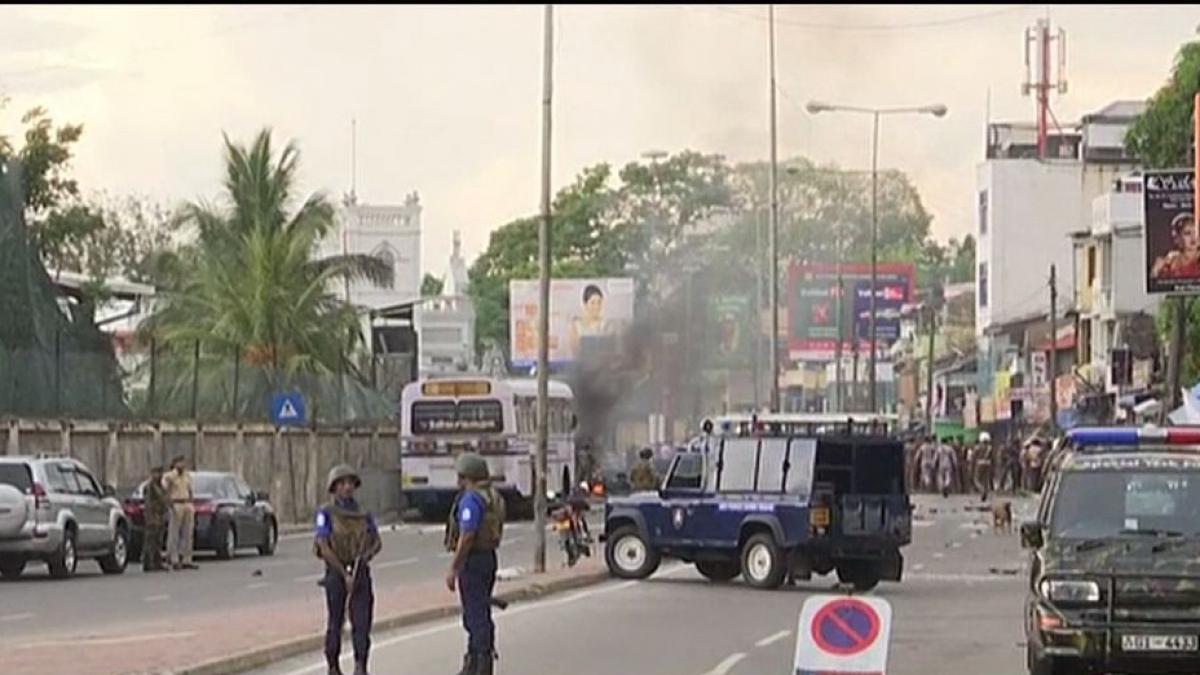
[787,263,914,362]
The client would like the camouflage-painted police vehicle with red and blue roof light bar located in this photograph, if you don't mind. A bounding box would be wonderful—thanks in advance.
[1021,426,1200,675]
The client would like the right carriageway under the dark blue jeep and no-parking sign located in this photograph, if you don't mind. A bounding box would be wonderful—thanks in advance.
[250,497,1032,675]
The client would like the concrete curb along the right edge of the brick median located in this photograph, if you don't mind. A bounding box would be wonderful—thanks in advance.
[168,569,608,675]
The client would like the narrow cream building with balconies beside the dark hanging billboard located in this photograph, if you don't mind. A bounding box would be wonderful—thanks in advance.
[1073,174,1158,394]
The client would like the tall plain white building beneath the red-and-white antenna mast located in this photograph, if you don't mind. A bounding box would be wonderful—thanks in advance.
[976,101,1145,408]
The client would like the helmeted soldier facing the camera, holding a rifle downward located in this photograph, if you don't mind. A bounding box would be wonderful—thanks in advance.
[313,464,383,675]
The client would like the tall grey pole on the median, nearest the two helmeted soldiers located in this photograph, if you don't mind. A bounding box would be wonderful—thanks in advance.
[533,5,554,574]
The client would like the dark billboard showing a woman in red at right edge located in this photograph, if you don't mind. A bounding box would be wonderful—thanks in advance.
[1142,171,1200,293]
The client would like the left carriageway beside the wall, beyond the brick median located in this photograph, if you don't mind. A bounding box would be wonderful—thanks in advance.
[0,511,592,649]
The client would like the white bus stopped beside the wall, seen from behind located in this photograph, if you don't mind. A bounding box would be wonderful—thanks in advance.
[400,377,576,519]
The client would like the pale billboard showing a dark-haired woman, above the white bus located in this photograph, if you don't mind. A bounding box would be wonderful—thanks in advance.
[509,279,634,368]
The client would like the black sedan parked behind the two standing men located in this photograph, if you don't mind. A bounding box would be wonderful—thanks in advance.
[125,471,280,560]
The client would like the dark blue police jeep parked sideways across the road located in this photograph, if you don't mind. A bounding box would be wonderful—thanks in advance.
[604,414,912,590]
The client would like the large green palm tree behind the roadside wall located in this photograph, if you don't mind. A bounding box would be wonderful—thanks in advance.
[148,130,392,417]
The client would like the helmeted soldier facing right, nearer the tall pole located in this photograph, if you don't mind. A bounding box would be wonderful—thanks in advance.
[445,453,504,675]
